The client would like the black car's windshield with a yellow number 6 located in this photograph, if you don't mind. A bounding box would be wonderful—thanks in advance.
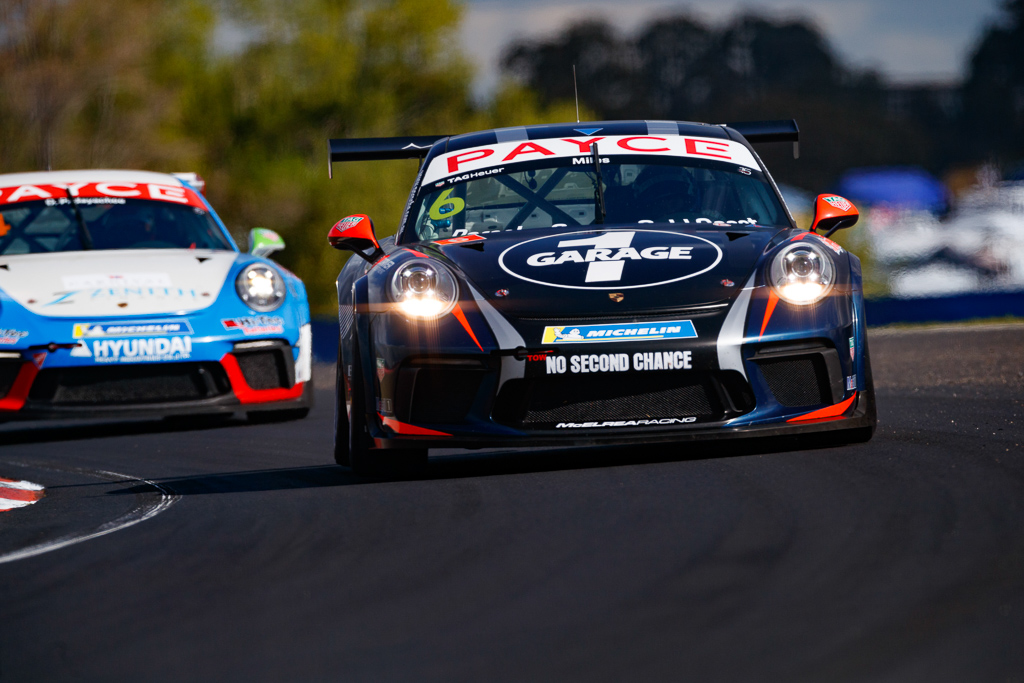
[407,143,791,241]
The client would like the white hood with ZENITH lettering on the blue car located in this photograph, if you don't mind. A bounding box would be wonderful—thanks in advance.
[0,249,238,317]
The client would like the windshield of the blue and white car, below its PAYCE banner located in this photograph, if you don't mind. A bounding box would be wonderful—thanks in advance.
[0,197,231,255]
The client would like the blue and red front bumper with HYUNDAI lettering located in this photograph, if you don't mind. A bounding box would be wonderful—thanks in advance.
[0,325,312,422]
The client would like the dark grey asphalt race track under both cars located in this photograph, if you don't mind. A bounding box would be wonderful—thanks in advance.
[0,326,1024,683]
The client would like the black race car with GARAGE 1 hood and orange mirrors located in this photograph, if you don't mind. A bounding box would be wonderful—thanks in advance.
[329,121,876,472]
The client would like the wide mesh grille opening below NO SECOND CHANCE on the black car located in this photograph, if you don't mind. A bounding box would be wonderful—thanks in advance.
[493,375,727,429]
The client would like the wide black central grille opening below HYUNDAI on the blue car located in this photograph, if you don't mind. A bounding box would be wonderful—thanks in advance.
[29,362,230,405]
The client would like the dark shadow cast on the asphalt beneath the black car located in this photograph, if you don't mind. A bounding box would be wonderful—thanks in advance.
[106,436,856,496]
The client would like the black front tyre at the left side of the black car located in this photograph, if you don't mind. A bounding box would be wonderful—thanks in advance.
[334,343,427,476]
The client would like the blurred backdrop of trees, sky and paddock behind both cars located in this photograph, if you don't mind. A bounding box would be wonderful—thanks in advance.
[0,0,1024,323]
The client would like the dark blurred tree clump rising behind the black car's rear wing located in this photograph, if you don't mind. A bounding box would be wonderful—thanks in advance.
[503,12,937,191]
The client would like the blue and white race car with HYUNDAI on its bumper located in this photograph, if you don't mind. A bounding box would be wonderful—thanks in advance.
[0,170,312,422]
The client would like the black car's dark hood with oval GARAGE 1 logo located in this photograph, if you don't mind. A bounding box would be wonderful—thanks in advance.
[426,224,777,317]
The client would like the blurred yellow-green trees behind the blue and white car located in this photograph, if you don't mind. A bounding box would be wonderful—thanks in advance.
[0,0,574,313]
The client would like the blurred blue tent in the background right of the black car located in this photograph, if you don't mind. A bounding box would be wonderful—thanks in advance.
[839,166,948,212]
